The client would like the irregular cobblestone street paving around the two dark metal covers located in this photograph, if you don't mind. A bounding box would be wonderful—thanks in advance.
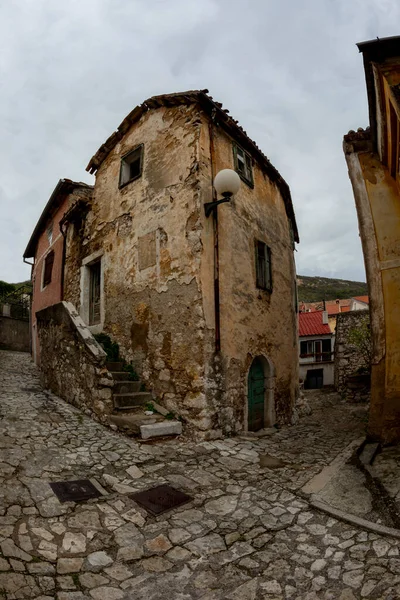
[0,352,400,600]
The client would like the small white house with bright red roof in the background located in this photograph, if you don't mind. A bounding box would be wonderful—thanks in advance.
[299,310,335,389]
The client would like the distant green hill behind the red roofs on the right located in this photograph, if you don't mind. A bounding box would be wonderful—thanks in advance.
[297,275,368,302]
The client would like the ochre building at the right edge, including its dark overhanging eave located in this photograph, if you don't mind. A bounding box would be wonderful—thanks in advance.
[343,37,400,443]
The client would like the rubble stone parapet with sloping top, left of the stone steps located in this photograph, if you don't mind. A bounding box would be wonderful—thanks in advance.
[36,302,113,424]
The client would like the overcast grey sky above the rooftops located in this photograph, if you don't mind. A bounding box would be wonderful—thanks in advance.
[0,0,400,281]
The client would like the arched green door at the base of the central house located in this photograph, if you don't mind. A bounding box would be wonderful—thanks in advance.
[247,356,275,431]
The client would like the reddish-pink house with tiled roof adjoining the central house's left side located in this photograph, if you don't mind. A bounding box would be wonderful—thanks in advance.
[23,179,93,364]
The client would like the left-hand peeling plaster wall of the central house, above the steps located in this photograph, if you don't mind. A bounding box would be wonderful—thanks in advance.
[65,106,209,429]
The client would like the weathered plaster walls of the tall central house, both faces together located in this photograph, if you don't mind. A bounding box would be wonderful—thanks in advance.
[64,94,298,436]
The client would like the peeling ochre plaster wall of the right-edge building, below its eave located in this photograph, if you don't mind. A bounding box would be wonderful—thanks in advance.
[344,134,400,443]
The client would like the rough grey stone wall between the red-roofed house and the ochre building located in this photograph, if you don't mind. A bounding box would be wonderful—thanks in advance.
[335,310,370,402]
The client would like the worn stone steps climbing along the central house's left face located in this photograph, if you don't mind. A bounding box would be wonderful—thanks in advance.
[106,362,182,438]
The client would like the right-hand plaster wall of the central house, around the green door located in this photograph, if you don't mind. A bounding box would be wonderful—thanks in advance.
[200,118,298,433]
